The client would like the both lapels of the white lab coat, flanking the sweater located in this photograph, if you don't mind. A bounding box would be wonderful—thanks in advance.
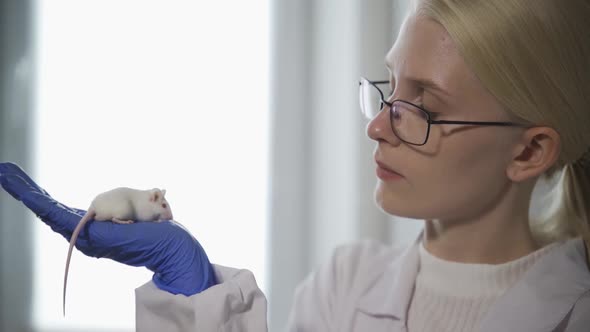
[357,230,590,332]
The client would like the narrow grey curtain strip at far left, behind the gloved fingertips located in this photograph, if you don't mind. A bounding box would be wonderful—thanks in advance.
[0,0,34,331]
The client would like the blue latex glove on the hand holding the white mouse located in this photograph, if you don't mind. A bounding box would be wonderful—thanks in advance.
[0,163,216,296]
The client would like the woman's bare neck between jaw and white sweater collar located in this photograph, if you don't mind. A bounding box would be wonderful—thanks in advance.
[424,179,539,264]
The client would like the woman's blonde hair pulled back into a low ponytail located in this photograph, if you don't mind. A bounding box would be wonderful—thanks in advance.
[413,0,590,249]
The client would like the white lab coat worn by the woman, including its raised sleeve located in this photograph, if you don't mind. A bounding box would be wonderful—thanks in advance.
[136,233,590,332]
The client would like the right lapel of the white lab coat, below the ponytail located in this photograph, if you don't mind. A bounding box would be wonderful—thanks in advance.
[481,238,590,332]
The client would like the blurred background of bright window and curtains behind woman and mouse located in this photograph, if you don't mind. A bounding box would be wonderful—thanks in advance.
[0,0,556,332]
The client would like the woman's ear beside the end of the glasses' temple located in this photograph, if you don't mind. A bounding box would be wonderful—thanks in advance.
[506,127,561,182]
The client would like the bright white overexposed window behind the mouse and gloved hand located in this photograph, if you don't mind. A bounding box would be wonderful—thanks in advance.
[33,0,269,331]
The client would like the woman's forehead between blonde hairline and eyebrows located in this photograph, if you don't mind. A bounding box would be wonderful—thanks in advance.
[385,15,474,94]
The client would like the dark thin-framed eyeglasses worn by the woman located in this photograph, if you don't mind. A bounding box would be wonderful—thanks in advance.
[359,77,527,145]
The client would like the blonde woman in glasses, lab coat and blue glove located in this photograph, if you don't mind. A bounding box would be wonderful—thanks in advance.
[0,0,590,332]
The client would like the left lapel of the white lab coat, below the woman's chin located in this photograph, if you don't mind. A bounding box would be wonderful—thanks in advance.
[357,231,423,325]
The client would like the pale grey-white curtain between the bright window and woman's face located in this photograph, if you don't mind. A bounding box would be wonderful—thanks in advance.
[268,0,422,331]
